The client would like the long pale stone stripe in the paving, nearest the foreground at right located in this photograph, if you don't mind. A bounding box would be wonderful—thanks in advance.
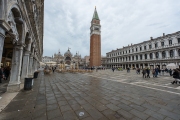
[82,75,180,95]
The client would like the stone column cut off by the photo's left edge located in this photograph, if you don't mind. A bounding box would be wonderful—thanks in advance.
[0,27,5,67]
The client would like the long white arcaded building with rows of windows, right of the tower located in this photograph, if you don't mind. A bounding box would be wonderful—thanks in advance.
[106,31,180,69]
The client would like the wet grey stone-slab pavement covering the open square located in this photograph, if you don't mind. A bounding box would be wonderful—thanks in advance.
[0,70,180,120]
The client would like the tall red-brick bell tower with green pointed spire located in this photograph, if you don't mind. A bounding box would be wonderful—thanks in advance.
[90,7,101,67]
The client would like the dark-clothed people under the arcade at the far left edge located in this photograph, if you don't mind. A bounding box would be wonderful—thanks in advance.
[0,67,10,83]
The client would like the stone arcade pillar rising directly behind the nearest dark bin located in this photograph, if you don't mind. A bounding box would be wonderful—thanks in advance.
[21,51,29,83]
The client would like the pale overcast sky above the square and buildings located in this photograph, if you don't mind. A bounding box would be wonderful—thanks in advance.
[44,0,180,57]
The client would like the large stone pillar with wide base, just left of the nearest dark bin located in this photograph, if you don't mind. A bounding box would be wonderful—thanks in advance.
[7,45,23,92]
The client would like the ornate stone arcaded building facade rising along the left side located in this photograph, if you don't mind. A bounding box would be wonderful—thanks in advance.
[0,0,44,92]
